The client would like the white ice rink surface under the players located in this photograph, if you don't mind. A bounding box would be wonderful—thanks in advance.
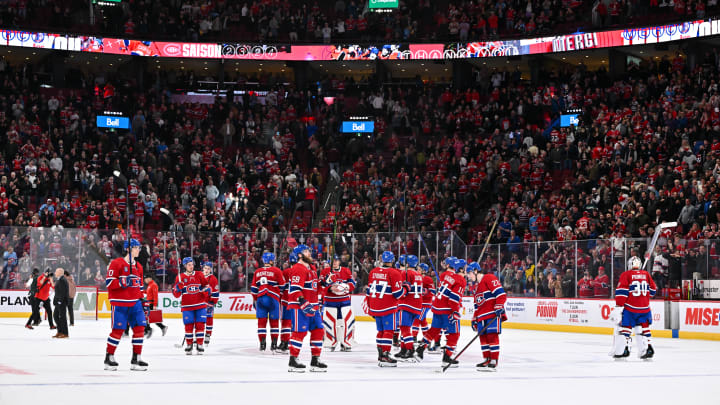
[0,319,720,405]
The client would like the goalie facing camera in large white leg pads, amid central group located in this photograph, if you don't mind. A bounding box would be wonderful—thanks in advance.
[320,256,355,352]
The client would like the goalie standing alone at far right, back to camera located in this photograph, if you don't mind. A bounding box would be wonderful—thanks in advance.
[610,256,657,360]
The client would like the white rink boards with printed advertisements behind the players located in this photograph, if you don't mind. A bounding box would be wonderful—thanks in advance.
[0,290,720,340]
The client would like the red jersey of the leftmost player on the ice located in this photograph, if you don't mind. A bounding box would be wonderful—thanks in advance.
[105,257,144,307]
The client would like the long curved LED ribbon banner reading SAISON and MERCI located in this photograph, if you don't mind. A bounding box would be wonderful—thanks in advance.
[0,18,720,61]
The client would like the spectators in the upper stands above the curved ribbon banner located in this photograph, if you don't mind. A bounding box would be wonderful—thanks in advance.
[2,0,717,43]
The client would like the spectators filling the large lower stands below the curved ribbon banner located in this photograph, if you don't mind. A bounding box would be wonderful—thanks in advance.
[0,41,720,296]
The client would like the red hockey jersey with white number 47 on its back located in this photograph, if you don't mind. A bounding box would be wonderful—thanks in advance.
[365,267,405,317]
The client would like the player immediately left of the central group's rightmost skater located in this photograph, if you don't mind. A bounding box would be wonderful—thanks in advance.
[415,259,466,367]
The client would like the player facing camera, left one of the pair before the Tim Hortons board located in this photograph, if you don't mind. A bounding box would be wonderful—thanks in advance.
[172,257,211,356]
